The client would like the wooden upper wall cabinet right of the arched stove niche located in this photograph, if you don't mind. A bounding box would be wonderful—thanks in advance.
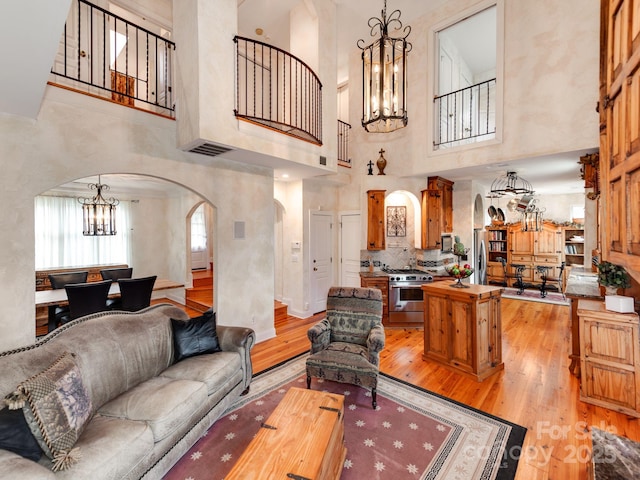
[421,177,453,250]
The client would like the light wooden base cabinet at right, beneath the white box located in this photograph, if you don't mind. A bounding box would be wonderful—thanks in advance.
[578,300,640,417]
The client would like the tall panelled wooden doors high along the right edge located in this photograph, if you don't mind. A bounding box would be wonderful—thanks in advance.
[598,0,640,282]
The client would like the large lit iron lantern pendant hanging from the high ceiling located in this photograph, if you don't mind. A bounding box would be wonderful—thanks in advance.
[357,0,411,133]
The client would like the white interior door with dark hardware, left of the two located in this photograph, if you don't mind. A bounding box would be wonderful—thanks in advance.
[309,212,333,314]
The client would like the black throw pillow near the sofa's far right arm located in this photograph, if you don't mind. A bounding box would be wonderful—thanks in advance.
[171,311,222,362]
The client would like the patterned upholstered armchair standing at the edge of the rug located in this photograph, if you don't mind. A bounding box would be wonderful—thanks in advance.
[306,287,385,409]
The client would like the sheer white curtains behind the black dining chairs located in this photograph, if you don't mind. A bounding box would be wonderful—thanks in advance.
[35,196,131,270]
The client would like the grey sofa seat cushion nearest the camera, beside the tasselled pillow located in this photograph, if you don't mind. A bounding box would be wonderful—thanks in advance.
[46,414,155,480]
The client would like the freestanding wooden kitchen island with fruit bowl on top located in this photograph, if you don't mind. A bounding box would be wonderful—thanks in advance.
[421,282,504,381]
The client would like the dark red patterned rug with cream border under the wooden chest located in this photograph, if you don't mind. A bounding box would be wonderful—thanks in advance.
[164,354,526,480]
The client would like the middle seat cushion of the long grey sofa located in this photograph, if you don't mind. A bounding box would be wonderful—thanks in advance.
[98,377,207,442]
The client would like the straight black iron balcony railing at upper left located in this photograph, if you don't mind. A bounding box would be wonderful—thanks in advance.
[51,0,175,117]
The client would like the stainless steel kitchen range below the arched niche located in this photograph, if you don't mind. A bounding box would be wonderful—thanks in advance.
[385,269,433,326]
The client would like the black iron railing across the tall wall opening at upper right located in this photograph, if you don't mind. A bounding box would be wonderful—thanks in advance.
[433,78,496,148]
